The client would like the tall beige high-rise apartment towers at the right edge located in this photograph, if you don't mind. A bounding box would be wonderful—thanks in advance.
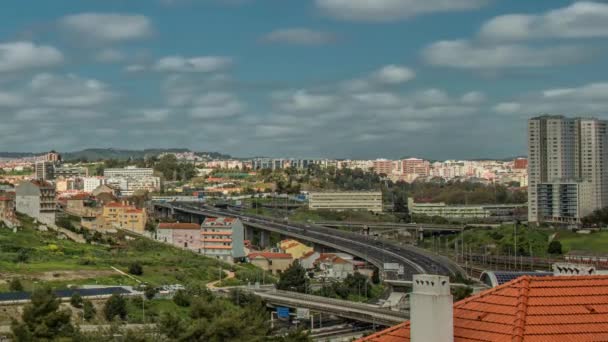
[528,115,608,222]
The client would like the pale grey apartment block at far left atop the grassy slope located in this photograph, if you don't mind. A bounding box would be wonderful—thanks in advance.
[15,180,57,225]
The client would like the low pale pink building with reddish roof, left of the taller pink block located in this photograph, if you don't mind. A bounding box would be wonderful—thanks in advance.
[154,222,201,248]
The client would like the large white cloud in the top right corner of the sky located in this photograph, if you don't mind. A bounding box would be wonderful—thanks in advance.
[479,1,608,40]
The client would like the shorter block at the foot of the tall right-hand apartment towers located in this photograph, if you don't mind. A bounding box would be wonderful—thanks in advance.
[536,181,593,224]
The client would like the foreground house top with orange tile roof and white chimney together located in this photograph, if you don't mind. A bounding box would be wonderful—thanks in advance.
[358,273,608,342]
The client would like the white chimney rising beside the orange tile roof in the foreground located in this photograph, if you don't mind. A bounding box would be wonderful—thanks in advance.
[410,274,454,342]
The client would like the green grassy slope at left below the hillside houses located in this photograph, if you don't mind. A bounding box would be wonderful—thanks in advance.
[0,214,241,289]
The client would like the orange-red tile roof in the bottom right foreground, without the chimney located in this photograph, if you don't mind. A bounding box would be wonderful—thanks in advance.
[359,275,608,342]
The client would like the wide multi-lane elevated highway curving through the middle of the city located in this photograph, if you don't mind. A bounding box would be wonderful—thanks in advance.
[156,203,465,279]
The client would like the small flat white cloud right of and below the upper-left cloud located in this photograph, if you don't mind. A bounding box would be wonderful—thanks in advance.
[154,56,232,72]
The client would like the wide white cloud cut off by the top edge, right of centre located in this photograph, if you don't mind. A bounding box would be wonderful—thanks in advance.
[315,0,488,22]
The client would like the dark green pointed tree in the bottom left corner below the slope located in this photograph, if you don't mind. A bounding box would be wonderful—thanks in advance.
[11,287,74,342]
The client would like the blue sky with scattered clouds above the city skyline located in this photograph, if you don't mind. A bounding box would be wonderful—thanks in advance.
[0,0,608,159]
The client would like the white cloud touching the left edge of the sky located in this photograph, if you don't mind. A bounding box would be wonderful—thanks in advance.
[0,42,63,72]
